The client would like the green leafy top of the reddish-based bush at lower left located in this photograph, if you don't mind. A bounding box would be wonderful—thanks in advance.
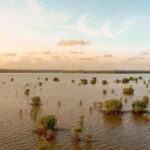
[38,115,57,131]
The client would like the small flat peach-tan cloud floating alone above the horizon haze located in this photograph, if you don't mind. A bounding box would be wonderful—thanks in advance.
[58,40,90,46]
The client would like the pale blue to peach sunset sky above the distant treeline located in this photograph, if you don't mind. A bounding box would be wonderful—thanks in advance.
[0,0,150,70]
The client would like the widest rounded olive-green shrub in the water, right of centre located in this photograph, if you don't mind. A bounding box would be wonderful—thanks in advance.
[102,99,123,114]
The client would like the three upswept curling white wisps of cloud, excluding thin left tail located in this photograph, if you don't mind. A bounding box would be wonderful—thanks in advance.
[76,15,135,39]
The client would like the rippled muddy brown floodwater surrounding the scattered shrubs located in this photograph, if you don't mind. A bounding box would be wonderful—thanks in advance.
[0,73,150,150]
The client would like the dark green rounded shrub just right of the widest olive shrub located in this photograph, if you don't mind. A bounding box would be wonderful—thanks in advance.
[132,100,147,114]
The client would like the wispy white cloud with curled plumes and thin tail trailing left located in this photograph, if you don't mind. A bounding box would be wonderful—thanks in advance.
[54,14,136,39]
